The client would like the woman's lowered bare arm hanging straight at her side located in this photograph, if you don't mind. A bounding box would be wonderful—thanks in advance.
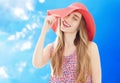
[88,42,101,83]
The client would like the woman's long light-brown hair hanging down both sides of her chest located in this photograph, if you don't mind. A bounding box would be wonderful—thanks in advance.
[51,17,91,83]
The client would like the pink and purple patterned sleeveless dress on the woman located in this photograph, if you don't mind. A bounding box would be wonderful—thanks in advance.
[50,45,92,83]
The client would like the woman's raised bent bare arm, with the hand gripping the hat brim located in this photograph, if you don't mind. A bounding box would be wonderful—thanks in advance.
[32,15,56,68]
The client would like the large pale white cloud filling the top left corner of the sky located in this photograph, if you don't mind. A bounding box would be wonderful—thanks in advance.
[0,0,35,20]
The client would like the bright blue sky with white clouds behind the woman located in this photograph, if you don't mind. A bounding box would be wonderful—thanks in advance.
[0,0,120,83]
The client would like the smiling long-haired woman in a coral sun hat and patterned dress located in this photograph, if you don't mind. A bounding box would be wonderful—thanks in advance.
[33,2,101,83]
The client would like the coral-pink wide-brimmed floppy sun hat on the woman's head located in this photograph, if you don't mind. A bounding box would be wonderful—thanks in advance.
[47,2,96,41]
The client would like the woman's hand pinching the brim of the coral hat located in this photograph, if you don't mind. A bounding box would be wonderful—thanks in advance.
[43,15,56,31]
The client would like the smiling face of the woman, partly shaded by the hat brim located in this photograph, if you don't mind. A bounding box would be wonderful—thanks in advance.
[60,11,82,32]
